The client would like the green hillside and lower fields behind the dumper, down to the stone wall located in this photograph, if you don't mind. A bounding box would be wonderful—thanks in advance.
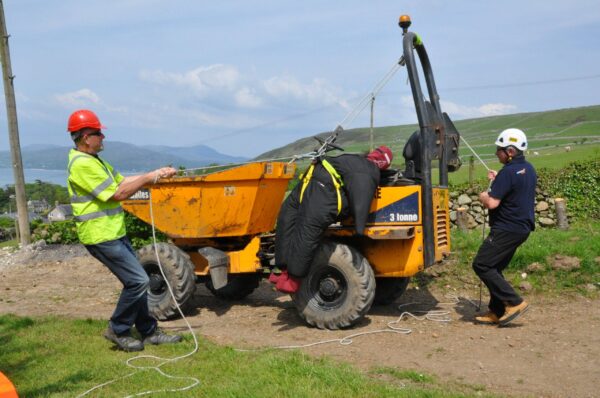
[259,106,600,183]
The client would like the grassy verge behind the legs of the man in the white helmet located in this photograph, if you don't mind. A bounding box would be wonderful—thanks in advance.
[440,221,600,296]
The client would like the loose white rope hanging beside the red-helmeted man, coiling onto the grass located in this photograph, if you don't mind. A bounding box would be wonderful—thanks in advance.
[77,190,200,398]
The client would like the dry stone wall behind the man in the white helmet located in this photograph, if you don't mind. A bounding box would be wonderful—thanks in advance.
[450,188,568,229]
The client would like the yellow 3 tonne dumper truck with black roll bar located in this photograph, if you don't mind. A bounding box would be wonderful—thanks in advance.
[123,16,460,329]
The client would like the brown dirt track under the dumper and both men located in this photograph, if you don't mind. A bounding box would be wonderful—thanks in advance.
[0,246,600,397]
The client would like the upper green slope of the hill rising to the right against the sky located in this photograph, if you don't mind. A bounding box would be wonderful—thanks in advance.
[256,105,600,163]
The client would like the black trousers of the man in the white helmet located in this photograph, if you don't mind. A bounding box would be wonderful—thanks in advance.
[473,228,529,317]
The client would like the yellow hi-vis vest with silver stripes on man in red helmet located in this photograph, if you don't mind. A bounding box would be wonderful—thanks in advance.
[67,149,125,245]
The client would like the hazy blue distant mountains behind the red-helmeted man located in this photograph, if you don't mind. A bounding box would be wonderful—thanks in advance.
[0,141,247,172]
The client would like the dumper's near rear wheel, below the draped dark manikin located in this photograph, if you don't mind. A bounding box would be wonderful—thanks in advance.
[292,242,375,329]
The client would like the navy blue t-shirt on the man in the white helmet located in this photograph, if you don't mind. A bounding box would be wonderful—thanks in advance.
[490,156,537,233]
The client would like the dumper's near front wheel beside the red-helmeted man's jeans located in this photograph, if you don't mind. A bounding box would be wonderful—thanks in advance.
[138,243,196,321]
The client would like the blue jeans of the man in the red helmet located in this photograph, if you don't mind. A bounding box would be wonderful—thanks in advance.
[85,236,157,336]
